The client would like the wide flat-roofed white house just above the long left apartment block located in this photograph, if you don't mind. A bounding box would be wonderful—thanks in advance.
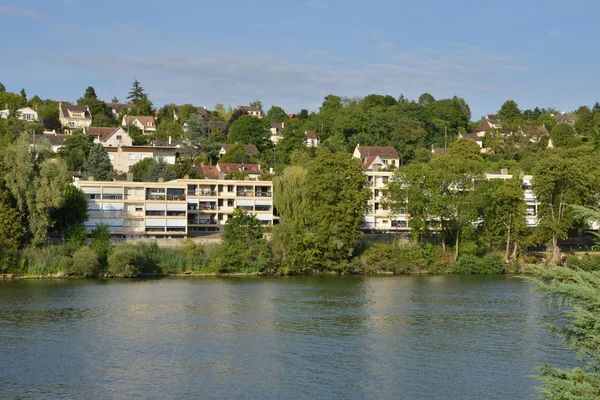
[105,146,179,173]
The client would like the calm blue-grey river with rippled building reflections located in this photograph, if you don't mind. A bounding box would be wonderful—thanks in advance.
[0,276,574,399]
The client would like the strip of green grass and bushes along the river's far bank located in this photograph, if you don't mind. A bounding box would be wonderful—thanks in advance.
[5,241,600,278]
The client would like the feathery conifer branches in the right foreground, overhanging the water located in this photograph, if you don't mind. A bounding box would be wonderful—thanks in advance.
[528,267,600,400]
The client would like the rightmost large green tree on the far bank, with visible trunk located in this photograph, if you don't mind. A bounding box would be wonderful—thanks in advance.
[532,151,598,262]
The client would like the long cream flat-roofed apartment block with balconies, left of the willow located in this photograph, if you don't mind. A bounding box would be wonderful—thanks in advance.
[75,175,274,239]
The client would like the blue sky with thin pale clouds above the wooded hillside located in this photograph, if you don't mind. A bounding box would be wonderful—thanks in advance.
[0,0,600,120]
